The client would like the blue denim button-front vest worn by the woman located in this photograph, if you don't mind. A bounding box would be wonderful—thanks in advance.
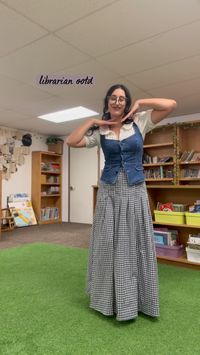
[100,123,144,185]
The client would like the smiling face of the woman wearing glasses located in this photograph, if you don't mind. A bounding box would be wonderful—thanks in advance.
[108,89,126,117]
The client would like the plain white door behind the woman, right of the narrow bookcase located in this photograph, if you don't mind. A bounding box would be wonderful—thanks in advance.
[69,147,98,224]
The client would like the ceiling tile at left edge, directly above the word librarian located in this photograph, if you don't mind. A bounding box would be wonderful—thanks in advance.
[0,35,88,83]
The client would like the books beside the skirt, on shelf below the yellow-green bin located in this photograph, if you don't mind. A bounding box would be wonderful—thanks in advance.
[154,227,180,246]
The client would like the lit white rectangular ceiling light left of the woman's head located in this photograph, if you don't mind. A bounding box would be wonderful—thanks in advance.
[38,106,99,123]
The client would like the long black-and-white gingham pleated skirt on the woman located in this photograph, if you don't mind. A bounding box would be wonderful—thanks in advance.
[87,170,159,321]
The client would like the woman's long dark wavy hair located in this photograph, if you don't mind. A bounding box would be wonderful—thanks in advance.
[87,84,133,136]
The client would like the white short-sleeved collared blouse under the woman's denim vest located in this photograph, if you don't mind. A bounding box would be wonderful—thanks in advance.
[84,110,155,148]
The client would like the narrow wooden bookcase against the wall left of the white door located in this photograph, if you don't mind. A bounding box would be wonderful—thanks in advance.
[32,151,62,224]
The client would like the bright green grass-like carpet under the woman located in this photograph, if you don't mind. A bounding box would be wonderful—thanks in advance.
[0,244,200,355]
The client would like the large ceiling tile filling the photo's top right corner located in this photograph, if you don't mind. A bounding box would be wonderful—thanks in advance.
[57,0,200,56]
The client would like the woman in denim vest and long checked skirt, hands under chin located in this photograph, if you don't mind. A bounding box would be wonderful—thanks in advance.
[67,85,176,321]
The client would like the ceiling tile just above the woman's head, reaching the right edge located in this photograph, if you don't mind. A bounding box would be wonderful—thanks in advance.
[98,21,200,75]
